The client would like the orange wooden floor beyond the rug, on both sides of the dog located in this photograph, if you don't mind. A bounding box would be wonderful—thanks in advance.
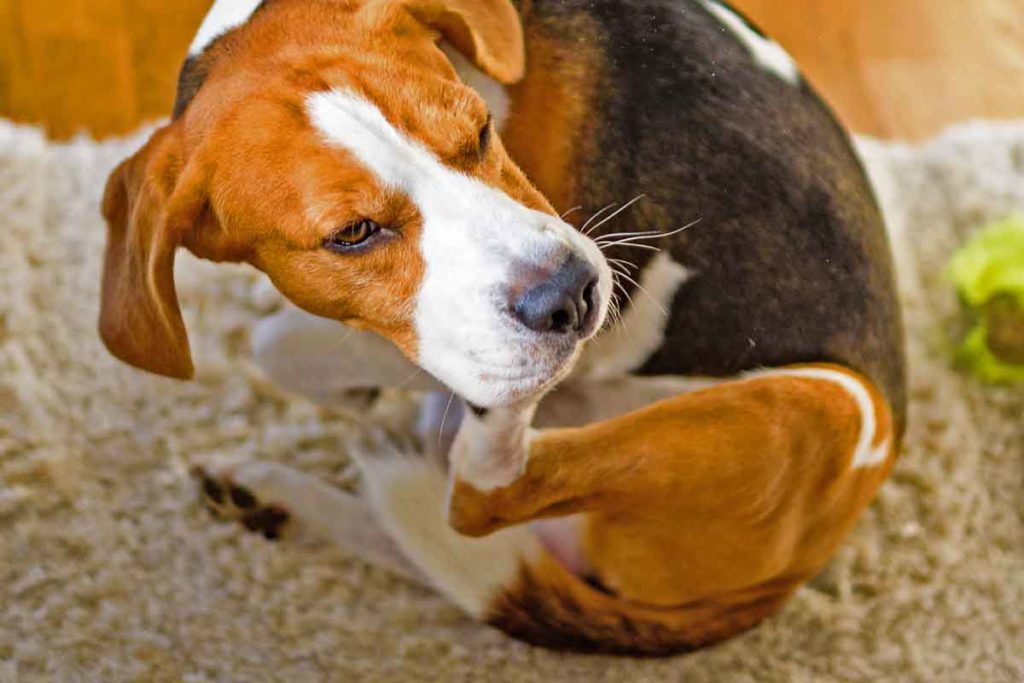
[0,0,1024,138]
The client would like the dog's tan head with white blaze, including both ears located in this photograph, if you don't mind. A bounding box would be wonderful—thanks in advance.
[99,0,611,405]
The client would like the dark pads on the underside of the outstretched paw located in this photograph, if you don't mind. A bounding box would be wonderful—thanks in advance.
[191,466,291,541]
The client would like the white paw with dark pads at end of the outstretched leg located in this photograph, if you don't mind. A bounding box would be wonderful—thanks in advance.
[191,462,292,541]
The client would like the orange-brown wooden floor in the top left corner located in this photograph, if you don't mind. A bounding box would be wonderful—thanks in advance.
[0,0,210,137]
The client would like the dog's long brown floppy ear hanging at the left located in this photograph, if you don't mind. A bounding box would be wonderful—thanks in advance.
[99,124,207,379]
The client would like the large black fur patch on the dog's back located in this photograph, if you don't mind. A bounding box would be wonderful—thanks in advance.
[529,0,905,428]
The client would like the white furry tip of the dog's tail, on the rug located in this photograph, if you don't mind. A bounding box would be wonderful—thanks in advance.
[353,452,544,618]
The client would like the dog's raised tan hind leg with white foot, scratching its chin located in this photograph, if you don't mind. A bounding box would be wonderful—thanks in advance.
[449,366,893,599]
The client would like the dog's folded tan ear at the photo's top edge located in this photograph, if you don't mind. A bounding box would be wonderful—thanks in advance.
[391,0,526,85]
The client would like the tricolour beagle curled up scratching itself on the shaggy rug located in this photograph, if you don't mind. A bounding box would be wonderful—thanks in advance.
[99,0,905,655]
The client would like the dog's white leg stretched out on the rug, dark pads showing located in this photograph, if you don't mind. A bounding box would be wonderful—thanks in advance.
[193,460,426,583]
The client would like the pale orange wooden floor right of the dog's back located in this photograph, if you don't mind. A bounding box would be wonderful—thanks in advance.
[733,0,1024,138]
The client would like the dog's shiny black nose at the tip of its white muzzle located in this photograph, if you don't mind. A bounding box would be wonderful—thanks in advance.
[512,256,597,334]
